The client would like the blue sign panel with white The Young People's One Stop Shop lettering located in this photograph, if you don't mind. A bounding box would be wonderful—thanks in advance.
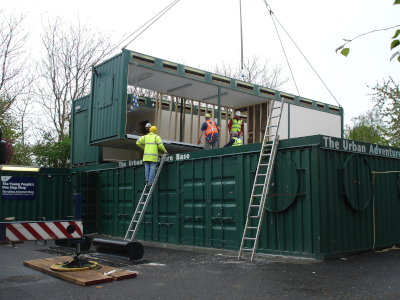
[1,176,36,200]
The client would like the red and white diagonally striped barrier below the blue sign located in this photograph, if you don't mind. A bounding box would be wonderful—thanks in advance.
[0,221,83,242]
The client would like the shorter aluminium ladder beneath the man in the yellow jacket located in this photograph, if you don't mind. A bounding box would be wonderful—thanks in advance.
[124,153,167,241]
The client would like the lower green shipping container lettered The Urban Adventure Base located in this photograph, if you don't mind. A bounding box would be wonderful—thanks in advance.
[73,135,400,259]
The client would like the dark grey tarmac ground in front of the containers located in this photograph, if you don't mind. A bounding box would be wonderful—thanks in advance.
[0,237,400,300]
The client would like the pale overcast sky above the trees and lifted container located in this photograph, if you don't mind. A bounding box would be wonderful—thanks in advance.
[1,0,400,123]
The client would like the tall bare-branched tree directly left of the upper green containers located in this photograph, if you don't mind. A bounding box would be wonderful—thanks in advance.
[34,18,113,166]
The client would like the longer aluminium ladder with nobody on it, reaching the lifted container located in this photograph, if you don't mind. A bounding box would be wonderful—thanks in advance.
[238,98,283,261]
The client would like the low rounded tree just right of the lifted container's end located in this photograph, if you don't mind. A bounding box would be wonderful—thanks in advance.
[344,107,388,145]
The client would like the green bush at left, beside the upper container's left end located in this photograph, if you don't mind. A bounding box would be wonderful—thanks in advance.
[32,133,71,168]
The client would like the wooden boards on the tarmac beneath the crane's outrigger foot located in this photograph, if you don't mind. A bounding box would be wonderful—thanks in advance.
[24,256,139,286]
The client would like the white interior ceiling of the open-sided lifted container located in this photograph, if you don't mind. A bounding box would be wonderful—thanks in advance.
[128,64,269,109]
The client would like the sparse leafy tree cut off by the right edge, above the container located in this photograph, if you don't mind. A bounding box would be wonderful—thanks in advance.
[371,77,400,147]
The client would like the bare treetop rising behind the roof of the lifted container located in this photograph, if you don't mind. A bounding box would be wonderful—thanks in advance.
[212,55,290,90]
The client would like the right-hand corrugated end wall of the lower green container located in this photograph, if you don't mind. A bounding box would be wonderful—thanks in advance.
[320,150,400,258]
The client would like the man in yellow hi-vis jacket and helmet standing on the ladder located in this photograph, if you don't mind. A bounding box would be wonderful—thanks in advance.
[136,123,168,185]
